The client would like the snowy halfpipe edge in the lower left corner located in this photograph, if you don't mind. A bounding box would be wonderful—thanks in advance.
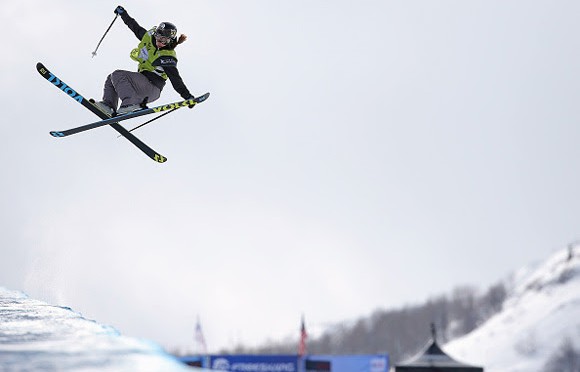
[0,287,201,372]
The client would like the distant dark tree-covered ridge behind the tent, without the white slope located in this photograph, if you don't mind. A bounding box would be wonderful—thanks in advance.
[222,284,508,364]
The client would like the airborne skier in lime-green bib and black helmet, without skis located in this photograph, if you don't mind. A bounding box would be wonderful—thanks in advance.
[96,5,195,115]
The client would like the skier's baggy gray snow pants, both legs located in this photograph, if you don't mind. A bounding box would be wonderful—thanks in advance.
[103,70,161,109]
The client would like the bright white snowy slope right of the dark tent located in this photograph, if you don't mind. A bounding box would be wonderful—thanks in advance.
[444,246,580,372]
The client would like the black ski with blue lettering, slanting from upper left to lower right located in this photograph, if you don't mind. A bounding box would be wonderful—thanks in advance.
[36,62,167,163]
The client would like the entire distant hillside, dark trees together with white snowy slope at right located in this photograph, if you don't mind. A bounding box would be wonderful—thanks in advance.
[231,245,580,372]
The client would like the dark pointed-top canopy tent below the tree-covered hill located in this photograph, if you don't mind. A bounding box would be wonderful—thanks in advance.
[395,325,483,372]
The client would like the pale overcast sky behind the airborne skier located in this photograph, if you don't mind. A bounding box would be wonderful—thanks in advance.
[0,0,580,351]
